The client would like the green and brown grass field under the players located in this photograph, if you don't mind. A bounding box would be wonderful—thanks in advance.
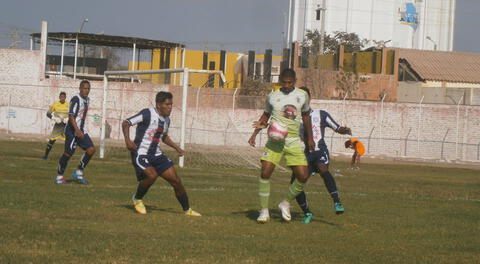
[0,140,480,263]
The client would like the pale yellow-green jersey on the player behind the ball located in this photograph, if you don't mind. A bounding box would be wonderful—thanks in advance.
[265,88,310,137]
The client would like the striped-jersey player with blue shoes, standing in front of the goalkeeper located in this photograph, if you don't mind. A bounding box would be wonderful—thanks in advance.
[55,80,95,184]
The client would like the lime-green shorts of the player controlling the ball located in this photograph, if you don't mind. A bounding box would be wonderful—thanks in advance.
[260,138,307,166]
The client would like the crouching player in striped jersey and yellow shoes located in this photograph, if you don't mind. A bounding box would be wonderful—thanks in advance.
[122,92,201,216]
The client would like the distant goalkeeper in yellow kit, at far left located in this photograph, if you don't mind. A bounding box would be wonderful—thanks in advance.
[41,92,68,160]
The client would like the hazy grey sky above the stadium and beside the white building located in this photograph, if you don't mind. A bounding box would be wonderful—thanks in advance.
[0,0,480,53]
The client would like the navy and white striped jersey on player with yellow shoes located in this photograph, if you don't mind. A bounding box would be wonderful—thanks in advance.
[127,107,170,156]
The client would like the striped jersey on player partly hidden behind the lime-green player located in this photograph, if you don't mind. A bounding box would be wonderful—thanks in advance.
[310,110,340,150]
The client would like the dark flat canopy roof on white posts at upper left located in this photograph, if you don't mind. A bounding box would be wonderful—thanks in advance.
[30,32,185,49]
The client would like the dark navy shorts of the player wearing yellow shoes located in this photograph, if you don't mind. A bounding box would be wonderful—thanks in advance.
[131,152,173,181]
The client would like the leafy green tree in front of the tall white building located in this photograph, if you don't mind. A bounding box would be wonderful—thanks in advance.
[302,29,369,55]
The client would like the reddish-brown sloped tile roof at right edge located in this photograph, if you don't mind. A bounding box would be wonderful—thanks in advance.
[399,49,480,83]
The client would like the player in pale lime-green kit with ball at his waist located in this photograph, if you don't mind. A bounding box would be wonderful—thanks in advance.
[248,69,315,223]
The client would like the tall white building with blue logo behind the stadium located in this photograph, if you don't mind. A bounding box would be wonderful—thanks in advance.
[287,0,456,51]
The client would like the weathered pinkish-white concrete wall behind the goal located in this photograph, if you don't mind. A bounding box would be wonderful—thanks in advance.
[0,50,480,161]
